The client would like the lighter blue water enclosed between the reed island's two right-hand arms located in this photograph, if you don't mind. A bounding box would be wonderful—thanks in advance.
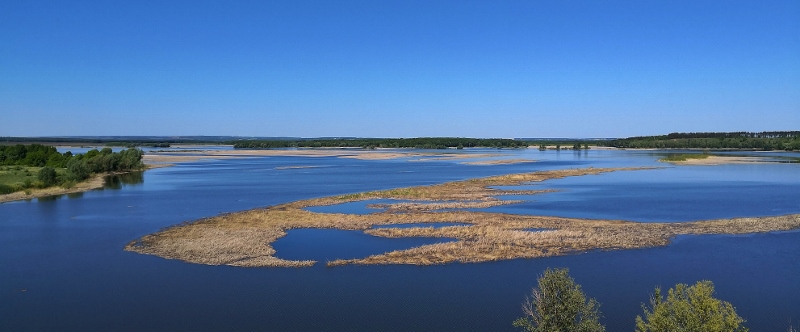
[485,164,800,222]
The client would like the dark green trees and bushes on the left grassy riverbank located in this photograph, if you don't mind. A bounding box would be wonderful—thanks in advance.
[0,144,144,185]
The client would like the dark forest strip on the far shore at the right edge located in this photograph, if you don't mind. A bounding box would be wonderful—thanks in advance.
[601,131,800,151]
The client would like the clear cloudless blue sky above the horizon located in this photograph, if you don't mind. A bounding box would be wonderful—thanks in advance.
[0,0,800,137]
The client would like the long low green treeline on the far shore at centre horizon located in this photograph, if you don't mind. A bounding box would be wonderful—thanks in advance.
[230,137,528,149]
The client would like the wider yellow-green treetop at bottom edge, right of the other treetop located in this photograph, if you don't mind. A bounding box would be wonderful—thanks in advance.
[636,280,747,332]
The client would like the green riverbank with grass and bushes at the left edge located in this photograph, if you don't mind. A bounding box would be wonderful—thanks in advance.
[0,144,144,194]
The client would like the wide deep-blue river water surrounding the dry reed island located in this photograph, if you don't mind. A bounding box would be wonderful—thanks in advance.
[0,149,800,331]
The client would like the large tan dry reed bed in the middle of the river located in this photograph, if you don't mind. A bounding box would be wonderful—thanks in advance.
[125,168,800,267]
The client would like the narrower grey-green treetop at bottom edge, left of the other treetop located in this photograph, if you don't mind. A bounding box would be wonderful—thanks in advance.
[514,268,605,332]
